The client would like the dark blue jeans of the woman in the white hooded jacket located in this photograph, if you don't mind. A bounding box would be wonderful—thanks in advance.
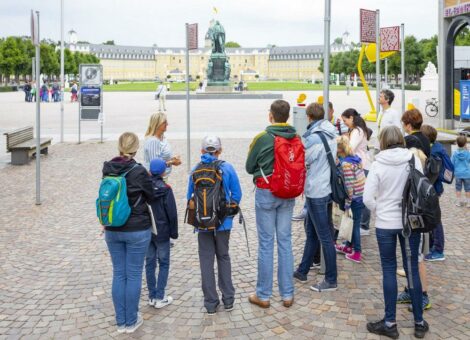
[376,228,423,322]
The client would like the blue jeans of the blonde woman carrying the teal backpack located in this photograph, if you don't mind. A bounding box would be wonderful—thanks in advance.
[105,228,151,326]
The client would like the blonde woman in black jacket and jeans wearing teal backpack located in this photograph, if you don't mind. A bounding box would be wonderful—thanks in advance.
[103,132,153,333]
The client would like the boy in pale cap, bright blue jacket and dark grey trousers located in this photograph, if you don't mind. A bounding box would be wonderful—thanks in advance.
[187,136,242,315]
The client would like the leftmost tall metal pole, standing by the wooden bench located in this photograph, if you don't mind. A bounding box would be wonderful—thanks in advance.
[35,11,41,205]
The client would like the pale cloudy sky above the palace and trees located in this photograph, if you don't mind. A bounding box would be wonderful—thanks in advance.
[0,0,438,47]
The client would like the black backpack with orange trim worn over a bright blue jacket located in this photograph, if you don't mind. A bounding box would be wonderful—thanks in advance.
[185,160,228,230]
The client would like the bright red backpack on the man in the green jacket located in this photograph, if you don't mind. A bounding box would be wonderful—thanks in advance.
[261,136,306,198]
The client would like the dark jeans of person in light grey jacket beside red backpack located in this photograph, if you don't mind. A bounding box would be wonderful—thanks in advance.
[297,195,338,284]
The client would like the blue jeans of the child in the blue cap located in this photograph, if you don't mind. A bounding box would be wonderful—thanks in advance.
[145,236,170,300]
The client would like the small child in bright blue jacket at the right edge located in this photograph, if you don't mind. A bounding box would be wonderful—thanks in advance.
[452,136,470,208]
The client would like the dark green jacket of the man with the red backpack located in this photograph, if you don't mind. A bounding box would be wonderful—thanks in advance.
[245,123,297,182]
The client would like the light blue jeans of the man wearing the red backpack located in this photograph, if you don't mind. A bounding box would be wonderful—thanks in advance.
[255,188,295,300]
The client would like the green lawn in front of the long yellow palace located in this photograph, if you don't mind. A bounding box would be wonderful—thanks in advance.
[100,81,359,92]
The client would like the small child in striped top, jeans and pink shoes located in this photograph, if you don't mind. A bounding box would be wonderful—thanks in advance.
[336,136,366,263]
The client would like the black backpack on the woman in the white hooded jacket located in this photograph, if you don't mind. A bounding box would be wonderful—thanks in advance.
[402,155,441,233]
